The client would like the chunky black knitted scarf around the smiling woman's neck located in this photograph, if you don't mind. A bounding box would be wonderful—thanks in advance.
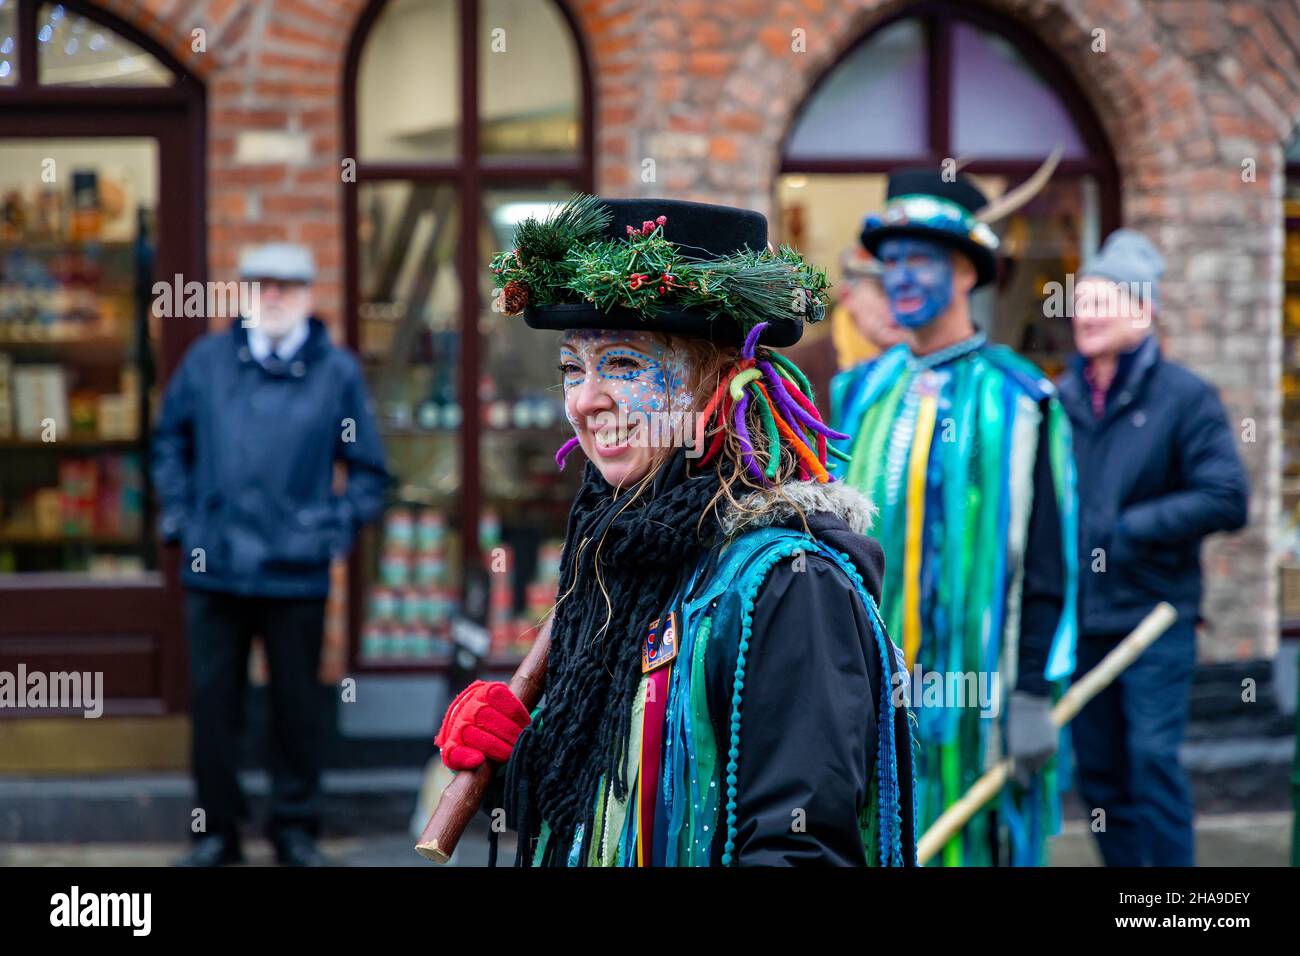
[506,451,720,866]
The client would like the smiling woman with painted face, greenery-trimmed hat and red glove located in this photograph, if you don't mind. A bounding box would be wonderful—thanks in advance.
[438,196,915,866]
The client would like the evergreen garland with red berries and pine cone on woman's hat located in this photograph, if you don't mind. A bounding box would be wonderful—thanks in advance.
[491,195,829,328]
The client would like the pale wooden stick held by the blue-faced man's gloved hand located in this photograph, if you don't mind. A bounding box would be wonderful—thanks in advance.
[917,601,1178,866]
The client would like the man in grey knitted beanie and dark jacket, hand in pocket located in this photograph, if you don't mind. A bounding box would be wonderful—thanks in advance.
[1058,229,1248,866]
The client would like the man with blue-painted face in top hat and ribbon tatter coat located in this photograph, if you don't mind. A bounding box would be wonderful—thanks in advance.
[831,169,1078,866]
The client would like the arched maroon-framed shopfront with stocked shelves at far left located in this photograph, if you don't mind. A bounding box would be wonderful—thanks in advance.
[0,0,207,714]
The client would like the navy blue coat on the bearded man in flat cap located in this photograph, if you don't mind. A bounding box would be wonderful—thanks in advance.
[152,319,389,597]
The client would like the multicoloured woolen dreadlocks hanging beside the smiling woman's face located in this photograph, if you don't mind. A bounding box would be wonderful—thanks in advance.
[555,323,849,485]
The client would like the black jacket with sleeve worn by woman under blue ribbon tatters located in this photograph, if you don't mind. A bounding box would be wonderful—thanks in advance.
[705,512,915,866]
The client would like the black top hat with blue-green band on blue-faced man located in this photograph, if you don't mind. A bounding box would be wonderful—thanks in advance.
[861,166,997,289]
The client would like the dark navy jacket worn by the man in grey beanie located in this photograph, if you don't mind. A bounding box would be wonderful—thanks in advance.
[1058,337,1249,635]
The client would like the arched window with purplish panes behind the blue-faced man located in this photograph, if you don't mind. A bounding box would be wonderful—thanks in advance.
[779,3,1119,372]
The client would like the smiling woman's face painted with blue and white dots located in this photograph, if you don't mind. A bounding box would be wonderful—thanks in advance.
[560,329,693,486]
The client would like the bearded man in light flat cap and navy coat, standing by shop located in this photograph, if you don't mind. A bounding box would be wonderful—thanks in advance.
[152,243,389,866]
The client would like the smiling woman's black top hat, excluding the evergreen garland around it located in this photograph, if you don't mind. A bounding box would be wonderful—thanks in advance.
[493,196,824,347]
